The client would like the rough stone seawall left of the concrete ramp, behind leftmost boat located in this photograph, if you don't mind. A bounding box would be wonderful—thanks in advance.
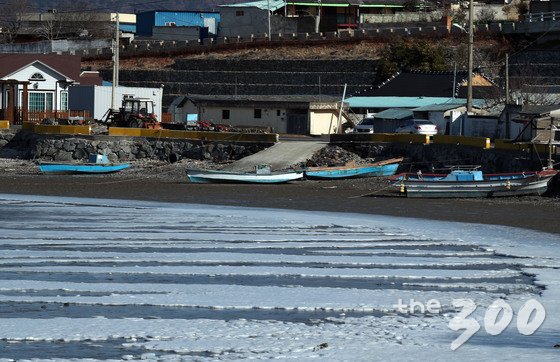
[0,131,272,162]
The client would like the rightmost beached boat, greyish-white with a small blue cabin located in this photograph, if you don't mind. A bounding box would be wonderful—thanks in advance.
[390,169,558,198]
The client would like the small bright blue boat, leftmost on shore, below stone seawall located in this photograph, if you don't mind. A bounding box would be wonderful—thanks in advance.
[39,154,130,174]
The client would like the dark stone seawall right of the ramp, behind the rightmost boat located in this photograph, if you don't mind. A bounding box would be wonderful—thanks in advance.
[336,143,545,173]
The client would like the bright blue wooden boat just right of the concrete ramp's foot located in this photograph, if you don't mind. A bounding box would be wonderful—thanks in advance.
[305,157,403,180]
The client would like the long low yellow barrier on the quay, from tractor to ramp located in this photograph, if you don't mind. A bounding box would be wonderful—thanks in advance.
[109,127,278,143]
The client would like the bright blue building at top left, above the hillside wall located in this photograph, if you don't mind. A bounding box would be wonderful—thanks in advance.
[136,10,220,36]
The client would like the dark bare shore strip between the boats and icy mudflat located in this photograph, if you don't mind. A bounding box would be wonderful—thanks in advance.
[0,159,560,234]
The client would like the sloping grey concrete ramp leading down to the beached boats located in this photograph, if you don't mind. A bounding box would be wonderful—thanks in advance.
[223,141,327,172]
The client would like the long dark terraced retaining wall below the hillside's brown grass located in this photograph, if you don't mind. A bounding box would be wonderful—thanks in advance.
[101,59,377,107]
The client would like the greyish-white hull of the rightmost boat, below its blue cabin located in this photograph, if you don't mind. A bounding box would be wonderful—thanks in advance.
[394,173,556,198]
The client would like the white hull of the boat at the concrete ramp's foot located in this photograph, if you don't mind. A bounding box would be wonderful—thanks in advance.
[187,169,303,184]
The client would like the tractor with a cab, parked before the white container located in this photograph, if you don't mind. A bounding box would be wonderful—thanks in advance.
[103,98,161,129]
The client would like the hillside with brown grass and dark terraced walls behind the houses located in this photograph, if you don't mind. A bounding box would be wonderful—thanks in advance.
[83,38,508,107]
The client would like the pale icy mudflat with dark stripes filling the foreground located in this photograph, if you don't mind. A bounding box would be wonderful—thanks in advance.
[0,195,560,361]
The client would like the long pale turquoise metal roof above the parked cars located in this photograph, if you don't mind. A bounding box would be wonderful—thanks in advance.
[345,96,484,108]
